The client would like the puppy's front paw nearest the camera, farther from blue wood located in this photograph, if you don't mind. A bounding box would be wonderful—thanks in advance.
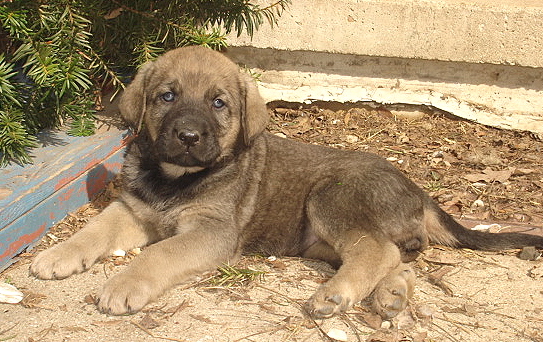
[97,273,159,315]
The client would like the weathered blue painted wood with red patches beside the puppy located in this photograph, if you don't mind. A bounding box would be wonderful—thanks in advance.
[0,128,129,270]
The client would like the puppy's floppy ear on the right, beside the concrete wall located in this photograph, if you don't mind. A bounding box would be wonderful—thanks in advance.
[241,74,270,146]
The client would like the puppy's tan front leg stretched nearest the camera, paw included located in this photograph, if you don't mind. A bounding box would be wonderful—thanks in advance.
[98,219,237,315]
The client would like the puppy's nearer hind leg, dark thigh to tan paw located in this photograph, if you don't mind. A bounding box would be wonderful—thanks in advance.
[306,182,401,318]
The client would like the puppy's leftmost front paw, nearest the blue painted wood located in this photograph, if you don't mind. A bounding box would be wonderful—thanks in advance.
[30,241,99,279]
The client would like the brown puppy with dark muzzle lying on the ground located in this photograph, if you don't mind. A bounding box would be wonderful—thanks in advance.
[30,47,543,317]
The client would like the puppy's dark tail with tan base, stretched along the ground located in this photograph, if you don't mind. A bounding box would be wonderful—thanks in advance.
[424,198,543,251]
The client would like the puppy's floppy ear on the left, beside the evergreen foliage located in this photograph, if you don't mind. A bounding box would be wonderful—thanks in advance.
[119,62,153,134]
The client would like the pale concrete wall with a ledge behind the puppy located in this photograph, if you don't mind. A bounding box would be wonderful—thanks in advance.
[228,0,543,134]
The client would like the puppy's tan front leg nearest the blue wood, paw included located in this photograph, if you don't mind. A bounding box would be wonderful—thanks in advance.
[30,201,154,279]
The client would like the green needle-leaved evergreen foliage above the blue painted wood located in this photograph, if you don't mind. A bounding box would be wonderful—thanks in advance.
[0,0,290,166]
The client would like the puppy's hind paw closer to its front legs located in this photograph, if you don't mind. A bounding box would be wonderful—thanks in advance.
[305,284,354,318]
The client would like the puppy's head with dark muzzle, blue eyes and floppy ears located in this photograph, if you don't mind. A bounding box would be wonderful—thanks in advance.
[120,47,268,174]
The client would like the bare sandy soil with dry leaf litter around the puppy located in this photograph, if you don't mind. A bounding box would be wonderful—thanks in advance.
[0,104,543,342]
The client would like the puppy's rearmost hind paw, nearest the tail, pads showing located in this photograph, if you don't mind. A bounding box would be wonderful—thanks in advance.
[373,265,415,319]
